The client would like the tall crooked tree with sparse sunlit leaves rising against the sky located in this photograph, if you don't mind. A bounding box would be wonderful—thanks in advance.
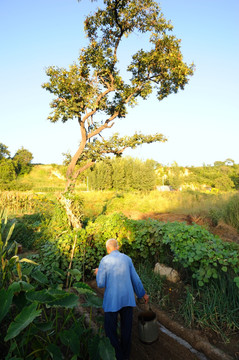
[42,0,193,225]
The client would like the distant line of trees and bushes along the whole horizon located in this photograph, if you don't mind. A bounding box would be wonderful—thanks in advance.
[0,143,239,191]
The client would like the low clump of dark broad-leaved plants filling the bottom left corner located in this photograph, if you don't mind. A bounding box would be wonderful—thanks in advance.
[0,269,115,360]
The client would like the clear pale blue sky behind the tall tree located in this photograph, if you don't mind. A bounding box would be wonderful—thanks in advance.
[0,0,239,166]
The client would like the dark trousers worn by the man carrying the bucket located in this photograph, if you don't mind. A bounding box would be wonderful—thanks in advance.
[104,306,133,360]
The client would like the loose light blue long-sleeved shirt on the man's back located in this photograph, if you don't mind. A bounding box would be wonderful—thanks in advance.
[96,250,145,312]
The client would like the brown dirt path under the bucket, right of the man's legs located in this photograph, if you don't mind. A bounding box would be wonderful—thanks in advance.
[88,280,233,360]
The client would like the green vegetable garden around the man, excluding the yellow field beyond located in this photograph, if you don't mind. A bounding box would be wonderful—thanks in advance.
[0,193,239,360]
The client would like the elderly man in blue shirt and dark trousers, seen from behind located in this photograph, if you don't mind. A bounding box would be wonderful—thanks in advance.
[95,239,149,360]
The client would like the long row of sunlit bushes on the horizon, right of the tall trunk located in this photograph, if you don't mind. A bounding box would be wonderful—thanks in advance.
[86,157,239,191]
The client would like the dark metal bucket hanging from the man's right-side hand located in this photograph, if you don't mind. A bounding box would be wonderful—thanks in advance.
[138,309,159,344]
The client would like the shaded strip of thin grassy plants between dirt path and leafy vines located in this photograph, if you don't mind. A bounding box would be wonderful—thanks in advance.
[136,262,239,343]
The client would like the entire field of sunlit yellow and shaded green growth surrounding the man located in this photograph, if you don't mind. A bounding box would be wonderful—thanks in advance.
[0,167,239,360]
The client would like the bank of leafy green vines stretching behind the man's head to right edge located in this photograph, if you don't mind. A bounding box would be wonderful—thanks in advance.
[39,213,239,286]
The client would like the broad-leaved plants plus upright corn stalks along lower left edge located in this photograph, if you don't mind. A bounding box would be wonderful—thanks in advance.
[0,214,115,360]
